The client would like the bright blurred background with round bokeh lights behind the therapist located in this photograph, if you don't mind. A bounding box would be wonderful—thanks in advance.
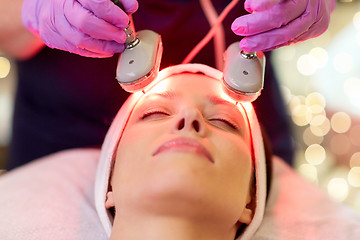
[0,0,360,210]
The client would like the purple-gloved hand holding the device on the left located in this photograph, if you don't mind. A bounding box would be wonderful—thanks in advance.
[22,0,138,58]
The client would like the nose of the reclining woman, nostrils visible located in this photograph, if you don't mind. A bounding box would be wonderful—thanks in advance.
[173,108,205,136]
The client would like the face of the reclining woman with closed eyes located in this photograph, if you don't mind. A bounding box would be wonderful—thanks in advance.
[107,73,253,223]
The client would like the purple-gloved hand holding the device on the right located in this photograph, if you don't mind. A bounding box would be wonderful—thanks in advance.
[231,0,336,52]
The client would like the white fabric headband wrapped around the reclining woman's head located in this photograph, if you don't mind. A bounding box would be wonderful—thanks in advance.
[95,64,266,240]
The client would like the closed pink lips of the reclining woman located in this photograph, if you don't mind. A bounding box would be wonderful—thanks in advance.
[153,137,214,163]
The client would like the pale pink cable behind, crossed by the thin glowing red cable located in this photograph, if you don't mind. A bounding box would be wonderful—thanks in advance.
[200,0,226,71]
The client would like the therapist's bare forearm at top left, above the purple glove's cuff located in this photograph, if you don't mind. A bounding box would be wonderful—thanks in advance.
[0,0,45,60]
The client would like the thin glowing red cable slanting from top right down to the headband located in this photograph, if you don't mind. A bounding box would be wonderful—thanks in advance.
[182,0,239,64]
